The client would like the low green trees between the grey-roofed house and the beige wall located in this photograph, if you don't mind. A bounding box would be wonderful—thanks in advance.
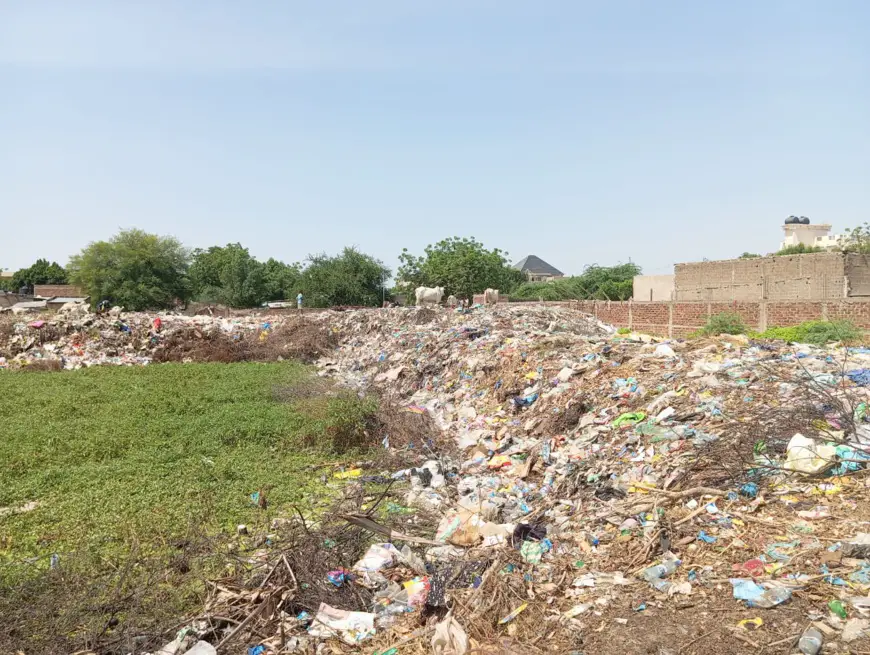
[512,263,641,300]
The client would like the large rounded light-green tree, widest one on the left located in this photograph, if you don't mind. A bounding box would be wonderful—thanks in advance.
[68,229,190,311]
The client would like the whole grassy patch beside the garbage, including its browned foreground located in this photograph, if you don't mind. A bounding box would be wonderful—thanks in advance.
[0,362,354,653]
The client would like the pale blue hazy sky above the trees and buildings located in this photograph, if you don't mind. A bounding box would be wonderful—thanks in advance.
[0,0,870,273]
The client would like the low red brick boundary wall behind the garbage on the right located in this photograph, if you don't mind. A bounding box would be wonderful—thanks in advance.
[524,298,870,337]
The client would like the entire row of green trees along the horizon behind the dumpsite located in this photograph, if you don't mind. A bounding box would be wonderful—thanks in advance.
[0,229,640,311]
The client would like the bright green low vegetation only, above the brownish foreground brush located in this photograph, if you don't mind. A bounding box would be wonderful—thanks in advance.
[0,363,334,568]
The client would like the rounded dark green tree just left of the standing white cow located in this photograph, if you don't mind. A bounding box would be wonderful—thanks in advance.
[299,248,390,307]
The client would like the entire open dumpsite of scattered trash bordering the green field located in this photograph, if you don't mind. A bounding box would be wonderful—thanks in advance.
[6,304,870,655]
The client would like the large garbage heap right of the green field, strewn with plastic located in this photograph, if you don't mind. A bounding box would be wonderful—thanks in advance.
[302,306,870,653]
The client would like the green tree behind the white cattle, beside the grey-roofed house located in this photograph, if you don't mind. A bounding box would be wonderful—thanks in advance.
[397,237,526,298]
